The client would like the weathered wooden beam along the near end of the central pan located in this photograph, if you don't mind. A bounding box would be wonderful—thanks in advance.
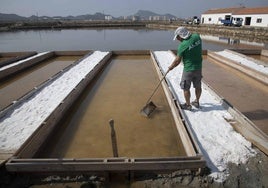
[6,156,205,173]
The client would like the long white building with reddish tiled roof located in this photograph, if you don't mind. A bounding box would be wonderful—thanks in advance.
[201,7,268,27]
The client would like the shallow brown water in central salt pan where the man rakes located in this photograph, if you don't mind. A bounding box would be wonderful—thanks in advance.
[37,56,185,158]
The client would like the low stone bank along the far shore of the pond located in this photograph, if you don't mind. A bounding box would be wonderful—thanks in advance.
[0,20,268,43]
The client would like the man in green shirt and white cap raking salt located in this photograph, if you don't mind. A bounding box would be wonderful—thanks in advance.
[169,27,202,110]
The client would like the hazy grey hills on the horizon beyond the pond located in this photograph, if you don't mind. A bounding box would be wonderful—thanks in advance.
[0,10,180,22]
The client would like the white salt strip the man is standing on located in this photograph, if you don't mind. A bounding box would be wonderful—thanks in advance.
[154,51,256,181]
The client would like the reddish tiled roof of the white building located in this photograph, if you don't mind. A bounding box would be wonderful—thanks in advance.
[203,7,268,15]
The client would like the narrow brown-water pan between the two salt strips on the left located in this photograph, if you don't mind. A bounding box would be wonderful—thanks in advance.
[0,56,81,110]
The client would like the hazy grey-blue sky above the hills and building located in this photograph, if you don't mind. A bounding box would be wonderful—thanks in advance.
[0,0,268,18]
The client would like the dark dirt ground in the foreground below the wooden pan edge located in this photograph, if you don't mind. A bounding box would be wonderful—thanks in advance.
[0,149,268,188]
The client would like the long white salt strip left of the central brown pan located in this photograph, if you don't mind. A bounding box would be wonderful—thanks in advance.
[0,51,108,151]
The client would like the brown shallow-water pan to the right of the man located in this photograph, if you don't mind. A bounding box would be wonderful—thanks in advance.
[204,58,268,134]
